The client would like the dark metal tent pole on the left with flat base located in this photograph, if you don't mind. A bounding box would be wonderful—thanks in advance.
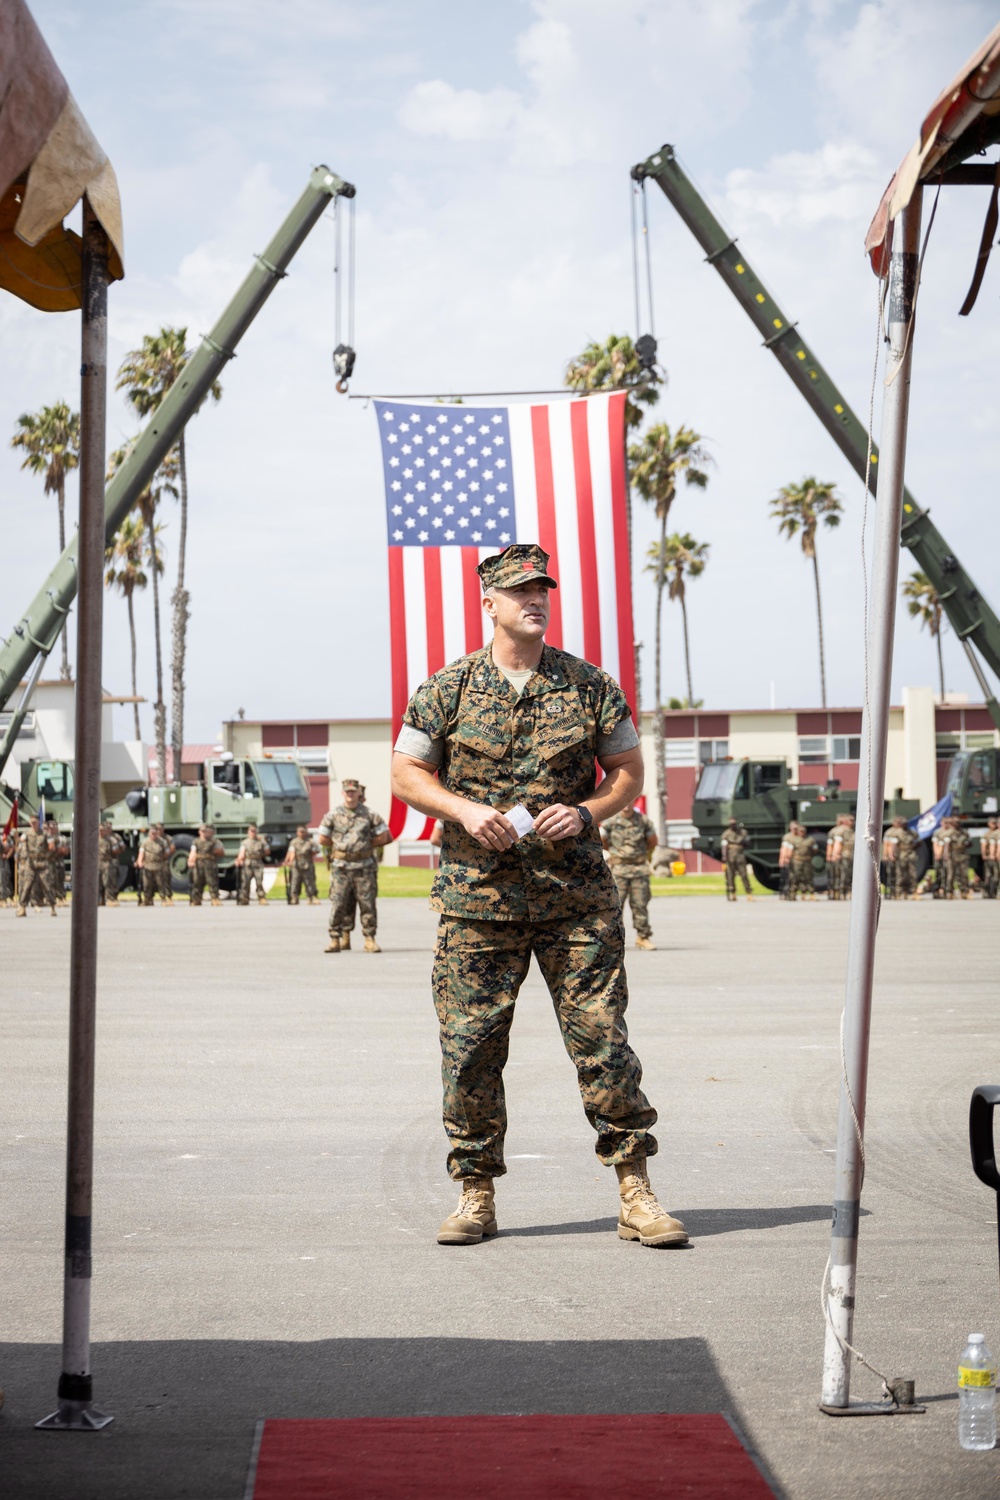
[37,198,111,1431]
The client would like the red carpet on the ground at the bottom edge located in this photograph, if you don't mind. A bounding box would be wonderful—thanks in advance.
[247,1413,774,1500]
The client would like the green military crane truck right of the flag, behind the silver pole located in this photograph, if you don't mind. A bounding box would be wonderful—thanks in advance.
[693,759,930,891]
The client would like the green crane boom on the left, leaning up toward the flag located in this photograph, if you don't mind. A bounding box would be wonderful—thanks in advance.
[0,167,354,726]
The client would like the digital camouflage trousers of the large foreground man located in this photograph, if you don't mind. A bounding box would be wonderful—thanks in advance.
[432,911,657,1178]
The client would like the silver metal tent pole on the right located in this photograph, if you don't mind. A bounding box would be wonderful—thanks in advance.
[822,185,922,1407]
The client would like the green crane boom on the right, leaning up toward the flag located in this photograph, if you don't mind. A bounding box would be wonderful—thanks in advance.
[631,146,1000,728]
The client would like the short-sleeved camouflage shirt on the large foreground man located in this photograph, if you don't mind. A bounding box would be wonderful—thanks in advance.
[397,645,630,923]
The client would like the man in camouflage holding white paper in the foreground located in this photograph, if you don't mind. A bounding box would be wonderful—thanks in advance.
[393,545,688,1247]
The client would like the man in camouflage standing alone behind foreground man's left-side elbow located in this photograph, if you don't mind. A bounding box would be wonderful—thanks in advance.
[319,777,393,953]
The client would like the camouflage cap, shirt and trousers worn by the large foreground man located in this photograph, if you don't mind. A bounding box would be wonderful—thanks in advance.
[396,567,657,1179]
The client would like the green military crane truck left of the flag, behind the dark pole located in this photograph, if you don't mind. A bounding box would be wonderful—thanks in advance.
[0,752,312,894]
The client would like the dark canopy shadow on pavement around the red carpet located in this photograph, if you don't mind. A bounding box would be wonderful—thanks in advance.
[0,1338,780,1500]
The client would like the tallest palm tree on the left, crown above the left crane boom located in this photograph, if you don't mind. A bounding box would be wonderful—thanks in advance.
[115,329,222,777]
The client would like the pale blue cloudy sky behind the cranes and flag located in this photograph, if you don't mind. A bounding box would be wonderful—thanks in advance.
[0,0,1000,741]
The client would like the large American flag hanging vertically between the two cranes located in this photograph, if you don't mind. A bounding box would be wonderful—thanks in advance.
[375,392,636,839]
